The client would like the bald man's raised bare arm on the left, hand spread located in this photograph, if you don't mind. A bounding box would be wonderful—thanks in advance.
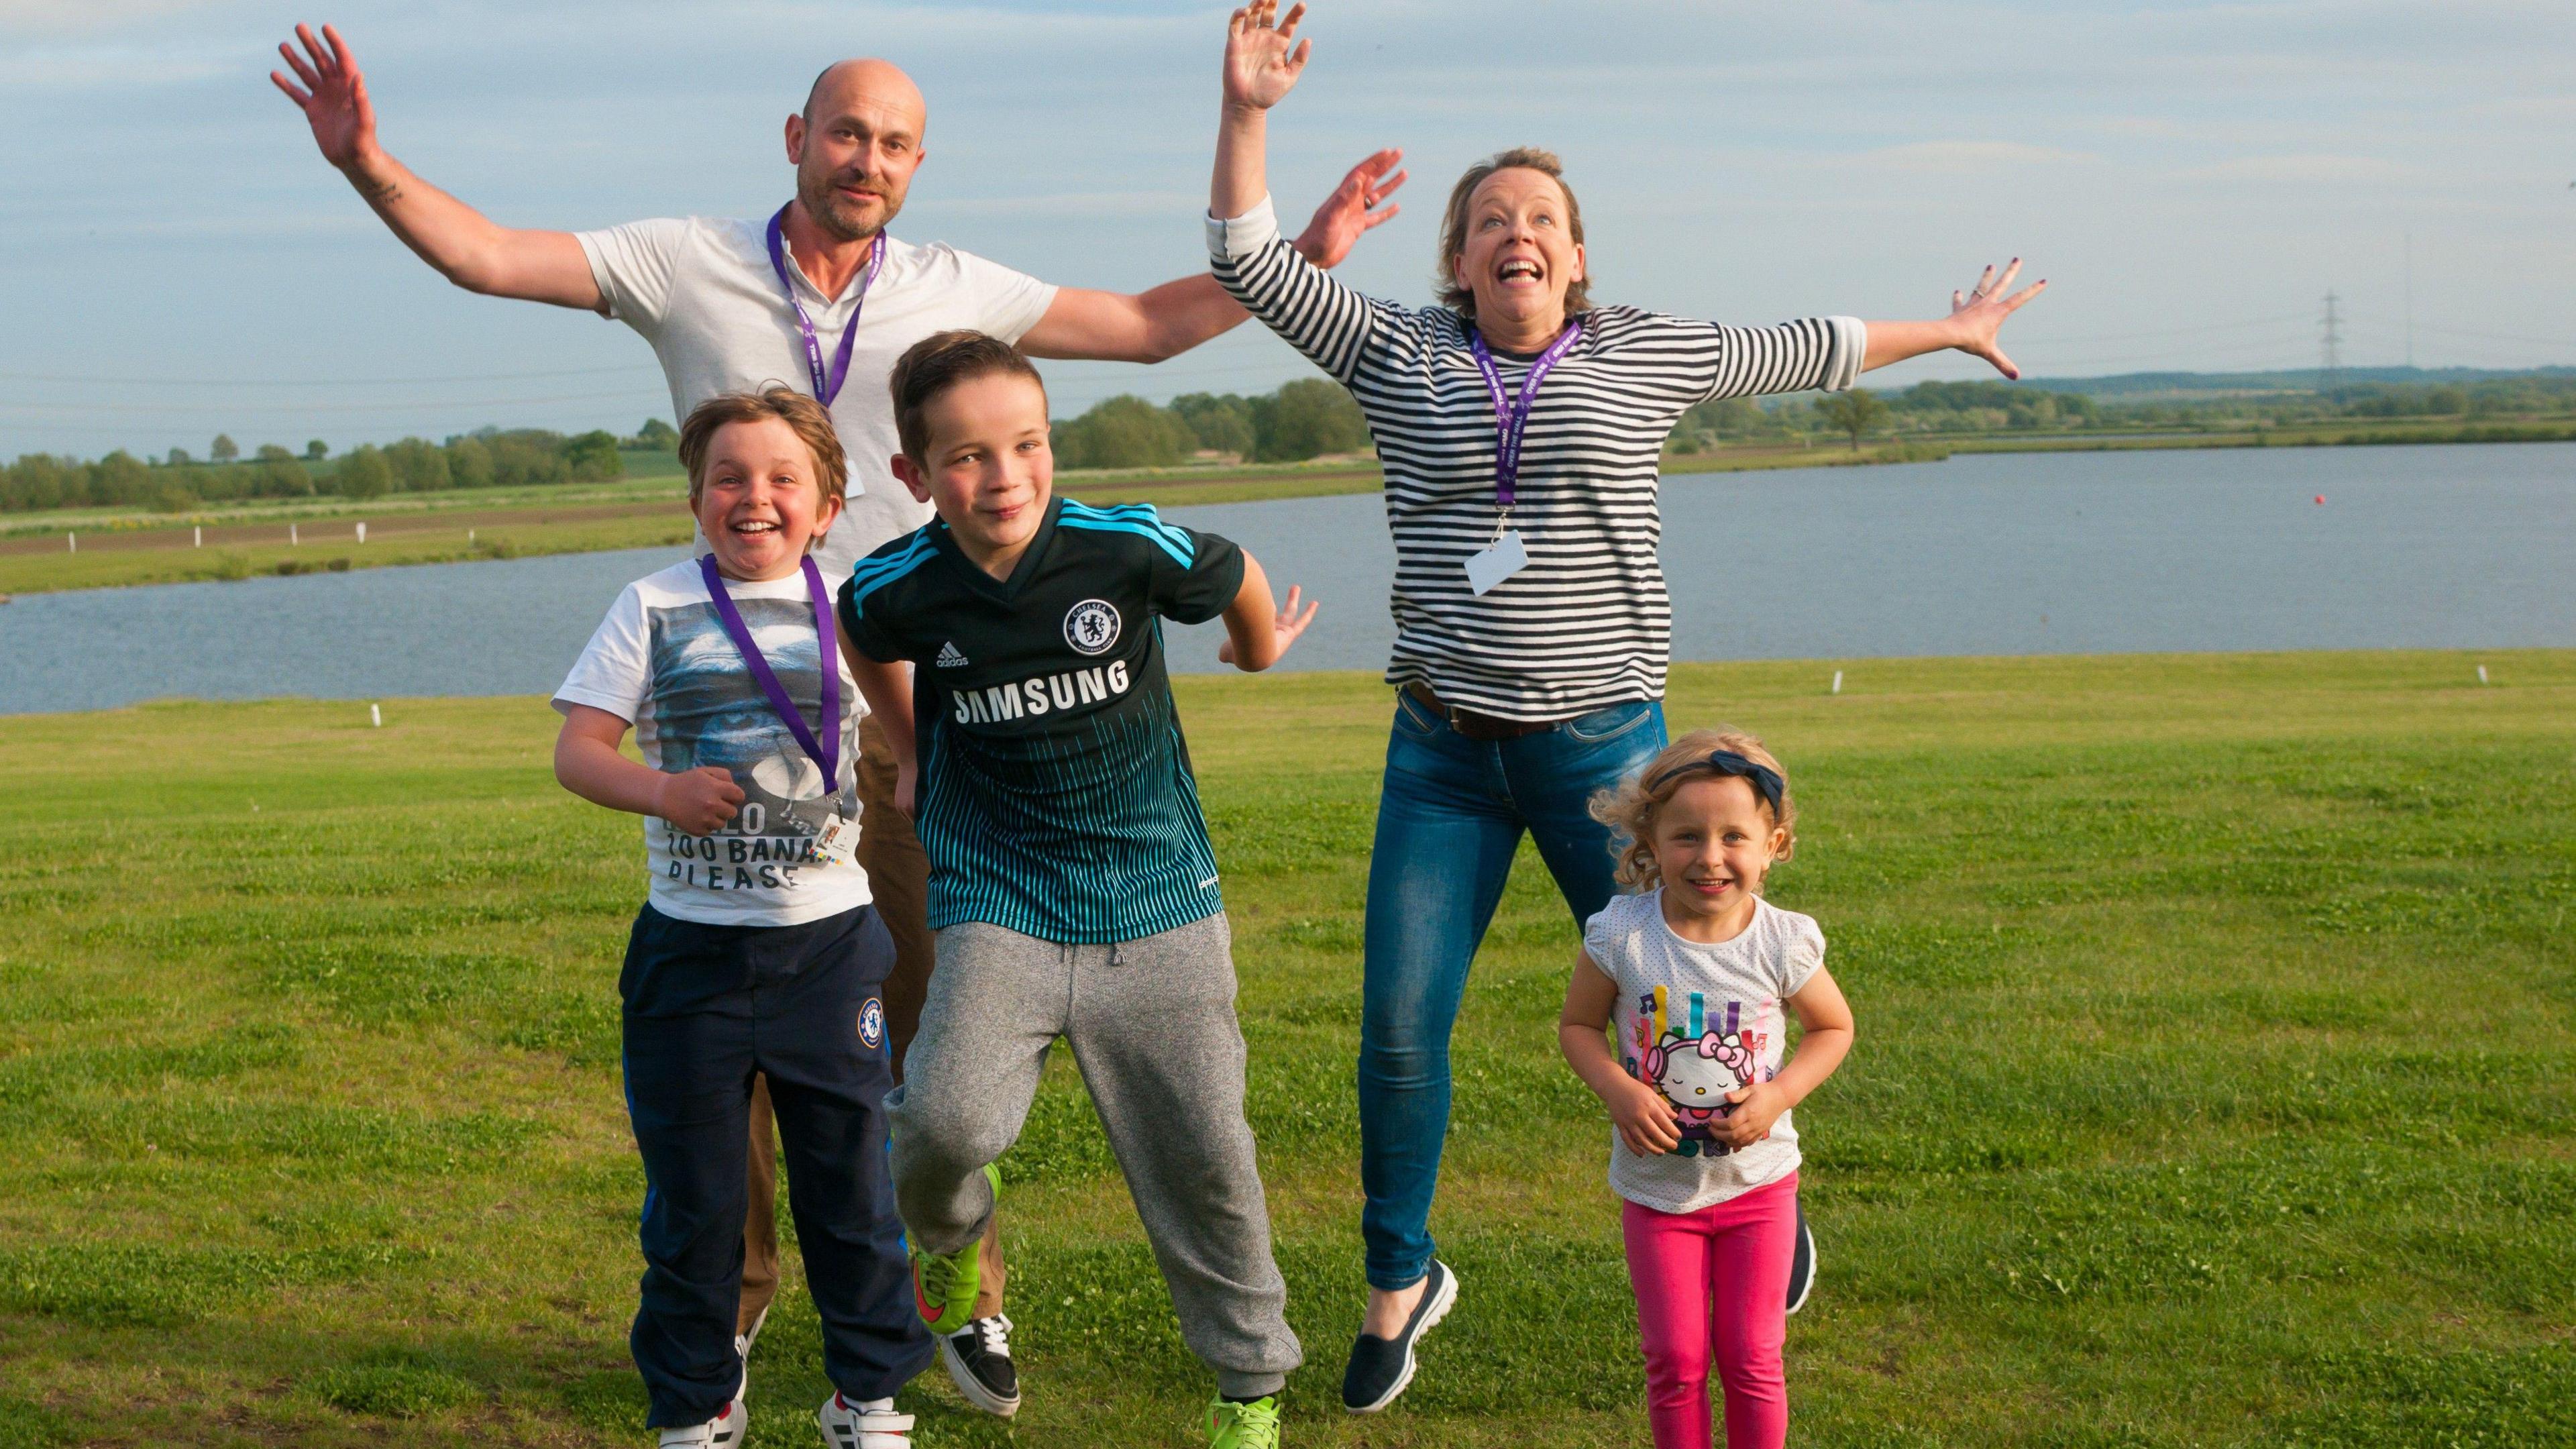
[268,25,600,312]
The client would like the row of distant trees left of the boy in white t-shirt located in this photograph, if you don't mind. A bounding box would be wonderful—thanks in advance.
[0,420,644,513]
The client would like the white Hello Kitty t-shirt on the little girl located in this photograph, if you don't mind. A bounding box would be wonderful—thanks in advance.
[1585,890,1824,1212]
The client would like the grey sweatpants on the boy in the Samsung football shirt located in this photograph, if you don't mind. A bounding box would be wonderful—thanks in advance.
[886,915,1303,1397]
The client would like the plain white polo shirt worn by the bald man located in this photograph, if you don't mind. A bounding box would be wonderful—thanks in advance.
[574,217,1056,575]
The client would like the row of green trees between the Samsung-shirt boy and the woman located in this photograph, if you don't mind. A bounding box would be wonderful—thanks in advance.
[1054,376,1368,470]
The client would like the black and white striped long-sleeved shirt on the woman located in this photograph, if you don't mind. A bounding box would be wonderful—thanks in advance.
[1208,199,1868,719]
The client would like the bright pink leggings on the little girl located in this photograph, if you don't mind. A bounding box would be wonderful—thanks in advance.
[1620,1173,1798,1449]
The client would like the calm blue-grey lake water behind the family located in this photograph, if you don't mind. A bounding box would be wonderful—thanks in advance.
[0,443,2576,714]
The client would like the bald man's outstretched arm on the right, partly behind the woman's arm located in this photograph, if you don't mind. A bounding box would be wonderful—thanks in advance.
[1020,150,1404,364]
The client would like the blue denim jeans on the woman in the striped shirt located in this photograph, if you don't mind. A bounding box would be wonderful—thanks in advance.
[1360,694,1664,1289]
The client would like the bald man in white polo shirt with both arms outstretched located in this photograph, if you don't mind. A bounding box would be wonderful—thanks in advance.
[270,25,1401,1415]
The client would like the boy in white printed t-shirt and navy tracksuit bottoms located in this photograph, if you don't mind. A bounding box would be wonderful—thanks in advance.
[554,387,932,1449]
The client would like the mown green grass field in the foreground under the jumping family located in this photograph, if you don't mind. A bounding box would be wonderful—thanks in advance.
[0,652,2576,1449]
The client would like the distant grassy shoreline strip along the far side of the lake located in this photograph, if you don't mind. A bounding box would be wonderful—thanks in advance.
[0,420,2576,596]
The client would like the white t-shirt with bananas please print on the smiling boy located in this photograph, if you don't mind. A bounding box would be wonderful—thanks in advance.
[554,559,868,926]
